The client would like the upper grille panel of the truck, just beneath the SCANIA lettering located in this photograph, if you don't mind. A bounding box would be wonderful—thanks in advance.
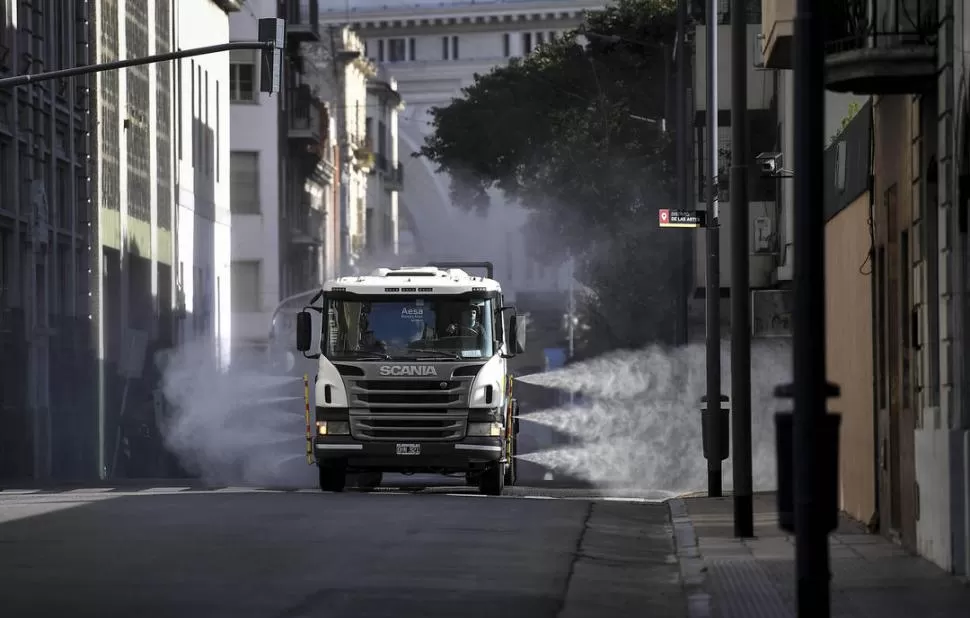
[348,378,471,411]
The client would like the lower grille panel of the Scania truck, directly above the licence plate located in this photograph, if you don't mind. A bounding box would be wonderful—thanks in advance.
[350,413,467,442]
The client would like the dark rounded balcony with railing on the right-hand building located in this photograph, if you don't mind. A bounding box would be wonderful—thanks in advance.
[820,0,939,95]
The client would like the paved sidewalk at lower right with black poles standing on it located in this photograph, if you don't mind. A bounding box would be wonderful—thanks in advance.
[668,494,970,618]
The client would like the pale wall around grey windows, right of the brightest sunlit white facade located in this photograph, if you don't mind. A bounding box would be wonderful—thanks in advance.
[229,0,281,342]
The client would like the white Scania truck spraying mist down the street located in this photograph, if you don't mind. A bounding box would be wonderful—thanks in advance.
[296,262,526,495]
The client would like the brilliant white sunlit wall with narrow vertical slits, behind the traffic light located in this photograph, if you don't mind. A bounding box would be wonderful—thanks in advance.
[175,0,232,366]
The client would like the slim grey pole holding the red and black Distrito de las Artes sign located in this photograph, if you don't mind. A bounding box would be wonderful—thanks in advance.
[704,0,726,498]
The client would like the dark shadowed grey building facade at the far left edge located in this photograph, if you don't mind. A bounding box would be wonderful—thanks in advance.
[0,0,99,479]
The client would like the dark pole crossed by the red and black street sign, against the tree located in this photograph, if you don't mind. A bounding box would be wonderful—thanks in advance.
[673,0,693,345]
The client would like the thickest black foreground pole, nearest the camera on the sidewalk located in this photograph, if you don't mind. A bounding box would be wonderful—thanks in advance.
[779,0,839,618]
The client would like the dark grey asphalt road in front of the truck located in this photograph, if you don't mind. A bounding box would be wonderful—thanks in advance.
[0,487,685,618]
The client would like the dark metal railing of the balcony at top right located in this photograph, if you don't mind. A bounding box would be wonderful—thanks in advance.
[822,0,939,54]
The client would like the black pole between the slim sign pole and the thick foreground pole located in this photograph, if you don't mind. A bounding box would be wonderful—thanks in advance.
[731,0,754,538]
